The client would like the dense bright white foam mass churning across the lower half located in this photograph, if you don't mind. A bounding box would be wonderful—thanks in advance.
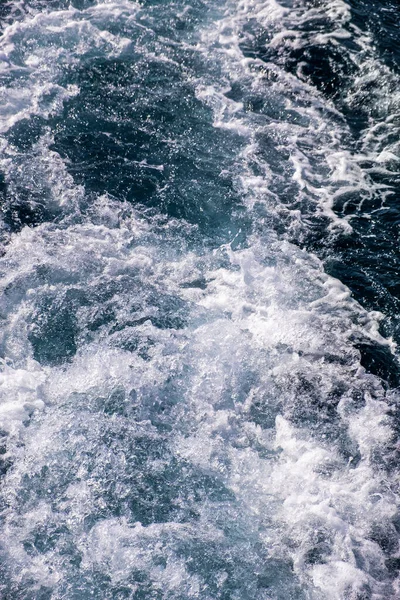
[3,206,396,599]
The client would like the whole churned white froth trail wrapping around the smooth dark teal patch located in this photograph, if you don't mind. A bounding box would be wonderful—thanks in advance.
[0,0,400,600]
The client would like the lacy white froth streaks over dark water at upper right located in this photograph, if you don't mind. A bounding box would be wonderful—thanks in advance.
[199,0,399,235]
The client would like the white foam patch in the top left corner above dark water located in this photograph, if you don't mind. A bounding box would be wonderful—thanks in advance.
[0,2,137,133]
